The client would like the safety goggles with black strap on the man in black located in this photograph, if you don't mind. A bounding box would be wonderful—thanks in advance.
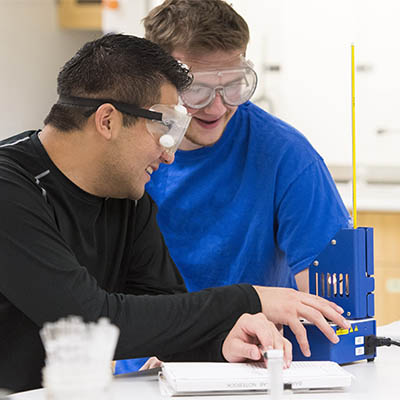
[57,96,191,154]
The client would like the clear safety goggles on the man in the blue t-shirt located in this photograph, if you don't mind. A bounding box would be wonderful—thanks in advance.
[181,60,257,109]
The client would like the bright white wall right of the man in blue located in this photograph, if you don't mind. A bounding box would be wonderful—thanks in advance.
[232,0,400,166]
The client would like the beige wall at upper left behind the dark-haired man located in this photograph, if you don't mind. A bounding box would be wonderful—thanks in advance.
[0,0,101,138]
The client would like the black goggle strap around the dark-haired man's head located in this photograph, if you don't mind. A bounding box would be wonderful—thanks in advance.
[57,96,162,121]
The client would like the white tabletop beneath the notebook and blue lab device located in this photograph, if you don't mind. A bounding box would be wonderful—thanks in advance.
[9,322,400,400]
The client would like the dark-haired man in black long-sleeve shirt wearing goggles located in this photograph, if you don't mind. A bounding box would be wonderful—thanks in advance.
[0,35,346,391]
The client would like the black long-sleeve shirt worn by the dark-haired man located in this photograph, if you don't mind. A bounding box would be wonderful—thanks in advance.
[0,131,261,391]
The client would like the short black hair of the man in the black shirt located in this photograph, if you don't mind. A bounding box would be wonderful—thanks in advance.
[44,34,191,131]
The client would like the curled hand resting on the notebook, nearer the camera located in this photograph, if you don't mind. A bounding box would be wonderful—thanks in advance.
[222,313,292,367]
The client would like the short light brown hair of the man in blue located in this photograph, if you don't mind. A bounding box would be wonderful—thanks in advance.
[143,0,250,53]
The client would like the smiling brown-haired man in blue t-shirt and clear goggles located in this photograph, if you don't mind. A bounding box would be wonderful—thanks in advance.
[115,0,349,374]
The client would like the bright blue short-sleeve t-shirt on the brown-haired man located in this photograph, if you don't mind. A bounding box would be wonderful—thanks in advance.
[115,102,349,376]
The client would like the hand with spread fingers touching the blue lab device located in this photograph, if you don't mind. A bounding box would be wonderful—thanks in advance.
[253,286,350,357]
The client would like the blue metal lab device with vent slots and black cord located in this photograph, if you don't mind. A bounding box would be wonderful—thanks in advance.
[284,227,376,364]
